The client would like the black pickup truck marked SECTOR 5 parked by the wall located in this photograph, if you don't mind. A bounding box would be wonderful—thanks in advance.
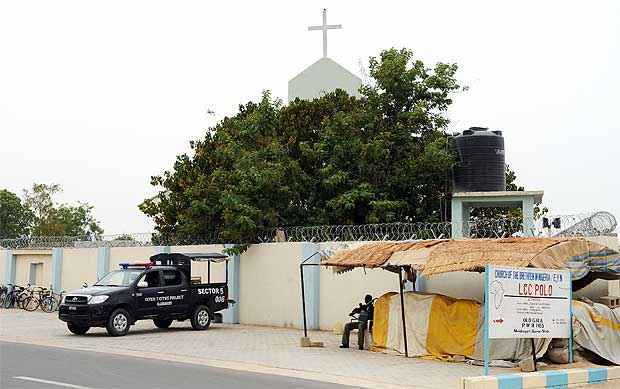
[58,253,234,336]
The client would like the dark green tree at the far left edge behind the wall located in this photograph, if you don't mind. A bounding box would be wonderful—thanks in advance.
[0,189,33,239]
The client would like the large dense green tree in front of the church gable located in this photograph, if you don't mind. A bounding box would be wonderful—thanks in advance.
[140,49,460,243]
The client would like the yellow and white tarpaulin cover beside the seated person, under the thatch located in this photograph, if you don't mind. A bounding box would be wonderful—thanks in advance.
[372,292,551,361]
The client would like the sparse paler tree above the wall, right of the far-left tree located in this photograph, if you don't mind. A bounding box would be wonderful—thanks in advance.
[24,183,103,238]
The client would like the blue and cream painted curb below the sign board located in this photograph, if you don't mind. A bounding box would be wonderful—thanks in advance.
[460,366,620,389]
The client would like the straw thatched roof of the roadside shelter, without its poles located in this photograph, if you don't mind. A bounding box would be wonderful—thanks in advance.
[321,238,618,275]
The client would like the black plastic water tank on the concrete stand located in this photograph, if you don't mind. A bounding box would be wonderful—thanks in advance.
[454,127,506,192]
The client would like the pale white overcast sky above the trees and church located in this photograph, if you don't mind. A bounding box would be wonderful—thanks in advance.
[0,0,620,233]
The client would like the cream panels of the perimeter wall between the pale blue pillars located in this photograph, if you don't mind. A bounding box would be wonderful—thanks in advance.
[0,233,620,330]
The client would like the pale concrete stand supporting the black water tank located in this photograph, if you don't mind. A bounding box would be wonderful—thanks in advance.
[452,190,544,238]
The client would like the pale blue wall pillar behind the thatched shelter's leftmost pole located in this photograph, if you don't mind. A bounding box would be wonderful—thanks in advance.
[299,242,321,330]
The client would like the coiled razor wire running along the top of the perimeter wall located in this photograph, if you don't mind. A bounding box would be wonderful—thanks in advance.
[0,212,617,249]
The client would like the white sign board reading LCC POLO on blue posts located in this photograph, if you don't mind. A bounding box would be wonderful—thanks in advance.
[485,266,571,338]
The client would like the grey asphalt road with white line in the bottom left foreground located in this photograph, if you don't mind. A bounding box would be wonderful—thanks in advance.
[0,342,356,389]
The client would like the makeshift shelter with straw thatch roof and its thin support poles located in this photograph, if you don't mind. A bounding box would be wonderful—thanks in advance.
[308,238,620,356]
